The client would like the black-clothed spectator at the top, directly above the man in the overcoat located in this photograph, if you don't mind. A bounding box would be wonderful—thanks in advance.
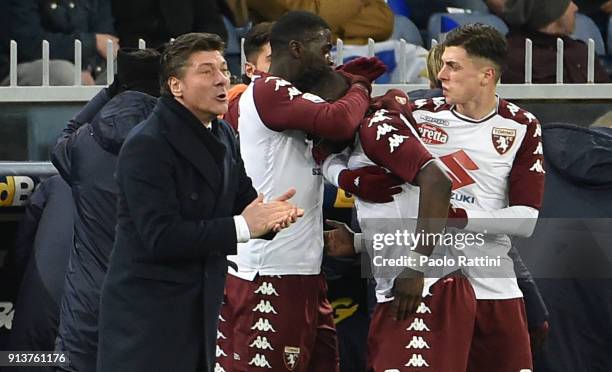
[108,0,232,48]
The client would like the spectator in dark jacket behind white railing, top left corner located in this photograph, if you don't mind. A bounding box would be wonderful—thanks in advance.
[3,0,119,85]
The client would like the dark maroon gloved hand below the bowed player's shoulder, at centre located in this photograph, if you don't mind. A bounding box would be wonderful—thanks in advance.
[338,165,404,203]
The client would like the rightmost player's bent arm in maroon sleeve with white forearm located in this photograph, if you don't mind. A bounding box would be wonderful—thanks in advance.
[449,120,546,237]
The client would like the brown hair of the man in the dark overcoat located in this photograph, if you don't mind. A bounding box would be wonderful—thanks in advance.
[160,32,225,94]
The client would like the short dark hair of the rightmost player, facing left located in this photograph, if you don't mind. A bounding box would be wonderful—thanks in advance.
[443,23,508,80]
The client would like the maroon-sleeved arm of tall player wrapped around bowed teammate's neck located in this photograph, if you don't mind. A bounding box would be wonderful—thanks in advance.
[254,76,370,141]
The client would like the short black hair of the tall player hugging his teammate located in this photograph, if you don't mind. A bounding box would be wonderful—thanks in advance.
[270,10,330,53]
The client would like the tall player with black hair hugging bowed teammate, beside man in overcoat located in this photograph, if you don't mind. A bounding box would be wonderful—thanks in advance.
[217,12,396,372]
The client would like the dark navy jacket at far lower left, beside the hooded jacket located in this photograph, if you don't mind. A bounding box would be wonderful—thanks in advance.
[6,176,74,372]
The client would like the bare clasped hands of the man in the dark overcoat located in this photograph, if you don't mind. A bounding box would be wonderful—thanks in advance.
[242,190,304,238]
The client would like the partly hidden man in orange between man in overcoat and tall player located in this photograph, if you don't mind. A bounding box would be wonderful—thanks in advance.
[224,22,274,132]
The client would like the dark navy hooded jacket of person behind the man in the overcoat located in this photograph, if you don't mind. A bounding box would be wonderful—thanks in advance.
[53,91,157,371]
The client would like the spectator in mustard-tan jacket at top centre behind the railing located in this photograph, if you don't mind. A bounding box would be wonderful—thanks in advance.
[245,0,394,44]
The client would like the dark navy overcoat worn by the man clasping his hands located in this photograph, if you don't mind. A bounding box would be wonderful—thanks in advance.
[97,97,256,372]
